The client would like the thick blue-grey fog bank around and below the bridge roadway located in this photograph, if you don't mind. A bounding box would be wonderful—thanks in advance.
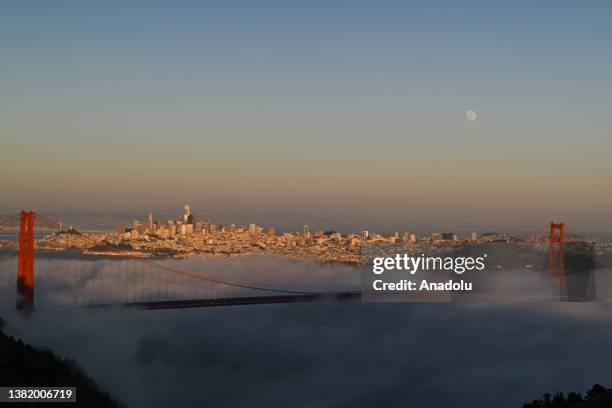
[0,253,612,407]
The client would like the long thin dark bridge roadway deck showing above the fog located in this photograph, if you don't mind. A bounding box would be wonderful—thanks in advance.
[89,292,361,310]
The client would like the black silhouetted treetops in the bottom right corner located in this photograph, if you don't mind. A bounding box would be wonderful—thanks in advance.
[523,384,612,408]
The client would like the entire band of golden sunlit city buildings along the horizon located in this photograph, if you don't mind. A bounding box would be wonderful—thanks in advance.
[0,205,612,264]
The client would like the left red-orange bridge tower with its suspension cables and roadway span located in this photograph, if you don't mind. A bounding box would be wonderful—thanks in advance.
[0,211,360,310]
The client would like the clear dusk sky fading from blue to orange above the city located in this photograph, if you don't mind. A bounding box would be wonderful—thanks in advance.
[0,1,612,232]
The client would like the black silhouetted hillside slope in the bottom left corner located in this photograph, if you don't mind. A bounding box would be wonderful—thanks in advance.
[0,319,123,408]
